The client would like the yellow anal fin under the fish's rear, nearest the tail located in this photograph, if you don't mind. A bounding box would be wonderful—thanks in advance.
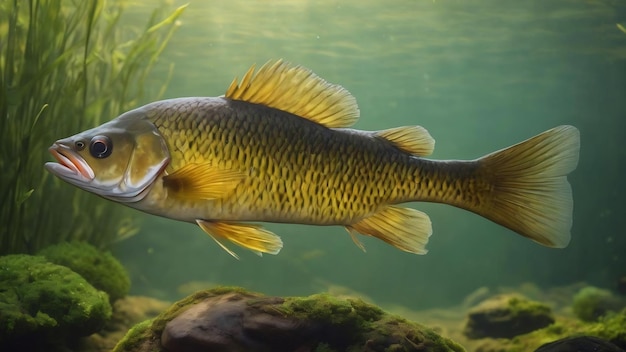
[346,206,433,254]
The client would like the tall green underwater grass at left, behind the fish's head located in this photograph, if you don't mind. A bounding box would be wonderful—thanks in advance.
[0,0,184,255]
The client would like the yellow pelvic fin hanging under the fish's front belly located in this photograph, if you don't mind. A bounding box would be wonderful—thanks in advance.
[196,220,283,259]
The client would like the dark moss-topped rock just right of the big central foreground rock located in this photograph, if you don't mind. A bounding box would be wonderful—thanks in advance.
[463,295,554,339]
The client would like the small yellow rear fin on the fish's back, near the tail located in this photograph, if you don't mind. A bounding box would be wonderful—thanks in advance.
[376,126,435,156]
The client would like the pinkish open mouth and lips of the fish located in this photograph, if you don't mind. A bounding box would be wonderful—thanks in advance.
[46,143,95,182]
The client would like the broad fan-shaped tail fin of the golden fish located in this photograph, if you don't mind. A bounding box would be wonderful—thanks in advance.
[473,126,580,248]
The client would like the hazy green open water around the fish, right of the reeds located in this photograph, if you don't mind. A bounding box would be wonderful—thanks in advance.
[113,0,626,309]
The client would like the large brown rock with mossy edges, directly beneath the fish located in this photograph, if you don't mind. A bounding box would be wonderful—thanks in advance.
[115,288,464,352]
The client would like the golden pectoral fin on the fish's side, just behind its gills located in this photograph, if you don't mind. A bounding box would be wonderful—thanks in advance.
[163,163,245,199]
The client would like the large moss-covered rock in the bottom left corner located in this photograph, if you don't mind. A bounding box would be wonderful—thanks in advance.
[0,255,111,351]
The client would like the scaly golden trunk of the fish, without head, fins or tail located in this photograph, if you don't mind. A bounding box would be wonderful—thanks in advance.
[136,97,460,225]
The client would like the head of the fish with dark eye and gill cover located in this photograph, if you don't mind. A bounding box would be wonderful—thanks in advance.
[45,109,170,203]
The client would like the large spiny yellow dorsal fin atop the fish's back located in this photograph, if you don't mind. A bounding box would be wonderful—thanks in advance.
[225,60,359,128]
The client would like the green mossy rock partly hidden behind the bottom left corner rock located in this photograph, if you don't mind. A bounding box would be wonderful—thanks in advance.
[38,241,130,302]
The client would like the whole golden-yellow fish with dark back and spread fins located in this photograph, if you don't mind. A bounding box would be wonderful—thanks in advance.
[45,59,580,258]
